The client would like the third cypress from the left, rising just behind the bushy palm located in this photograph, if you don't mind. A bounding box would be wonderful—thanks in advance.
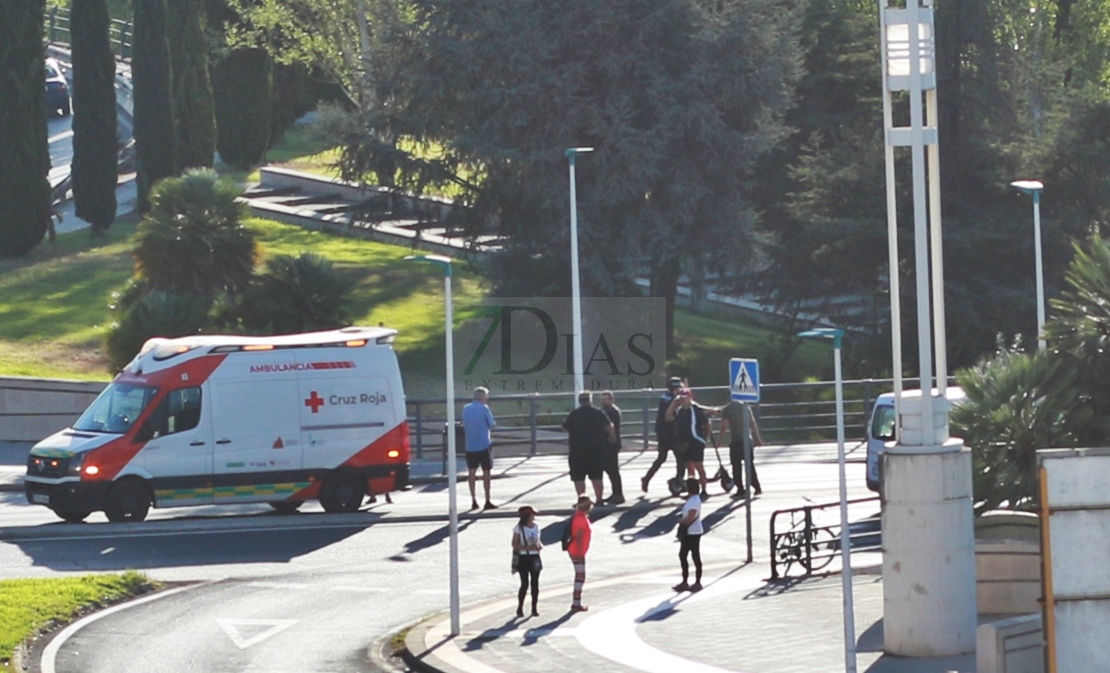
[131,0,178,212]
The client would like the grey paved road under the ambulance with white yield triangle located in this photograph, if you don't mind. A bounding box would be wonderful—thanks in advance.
[0,453,864,673]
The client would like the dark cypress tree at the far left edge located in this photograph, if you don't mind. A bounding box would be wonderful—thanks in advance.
[0,0,51,257]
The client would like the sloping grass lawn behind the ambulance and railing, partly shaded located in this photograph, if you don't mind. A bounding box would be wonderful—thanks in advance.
[0,218,831,399]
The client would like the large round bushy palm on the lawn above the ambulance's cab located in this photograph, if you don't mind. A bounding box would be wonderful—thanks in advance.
[133,169,259,302]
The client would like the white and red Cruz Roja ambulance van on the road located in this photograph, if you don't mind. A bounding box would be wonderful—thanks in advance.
[26,327,410,521]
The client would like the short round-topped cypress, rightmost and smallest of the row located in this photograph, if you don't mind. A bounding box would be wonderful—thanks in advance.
[212,49,273,169]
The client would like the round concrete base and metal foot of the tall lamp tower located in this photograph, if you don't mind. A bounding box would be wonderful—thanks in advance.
[881,399,977,656]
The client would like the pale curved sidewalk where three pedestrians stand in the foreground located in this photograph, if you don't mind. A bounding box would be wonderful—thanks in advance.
[405,564,975,673]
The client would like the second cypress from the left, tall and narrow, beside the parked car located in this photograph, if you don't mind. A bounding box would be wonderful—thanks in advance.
[70,0,119,235]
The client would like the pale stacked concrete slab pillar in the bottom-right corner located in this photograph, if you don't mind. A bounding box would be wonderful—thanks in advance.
[1037,449,1110,673]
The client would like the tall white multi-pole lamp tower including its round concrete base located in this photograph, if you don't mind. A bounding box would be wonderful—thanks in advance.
[879,0,976,656]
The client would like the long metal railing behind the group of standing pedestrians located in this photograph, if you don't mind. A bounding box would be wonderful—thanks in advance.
[407,379,916,459]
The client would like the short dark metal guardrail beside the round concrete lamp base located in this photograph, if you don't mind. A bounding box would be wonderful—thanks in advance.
[770,498,882,580]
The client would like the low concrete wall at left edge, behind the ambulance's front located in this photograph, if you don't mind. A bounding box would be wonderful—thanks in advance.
[0,376,108,442]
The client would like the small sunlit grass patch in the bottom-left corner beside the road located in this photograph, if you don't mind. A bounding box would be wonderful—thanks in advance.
[0,571,152,667]
